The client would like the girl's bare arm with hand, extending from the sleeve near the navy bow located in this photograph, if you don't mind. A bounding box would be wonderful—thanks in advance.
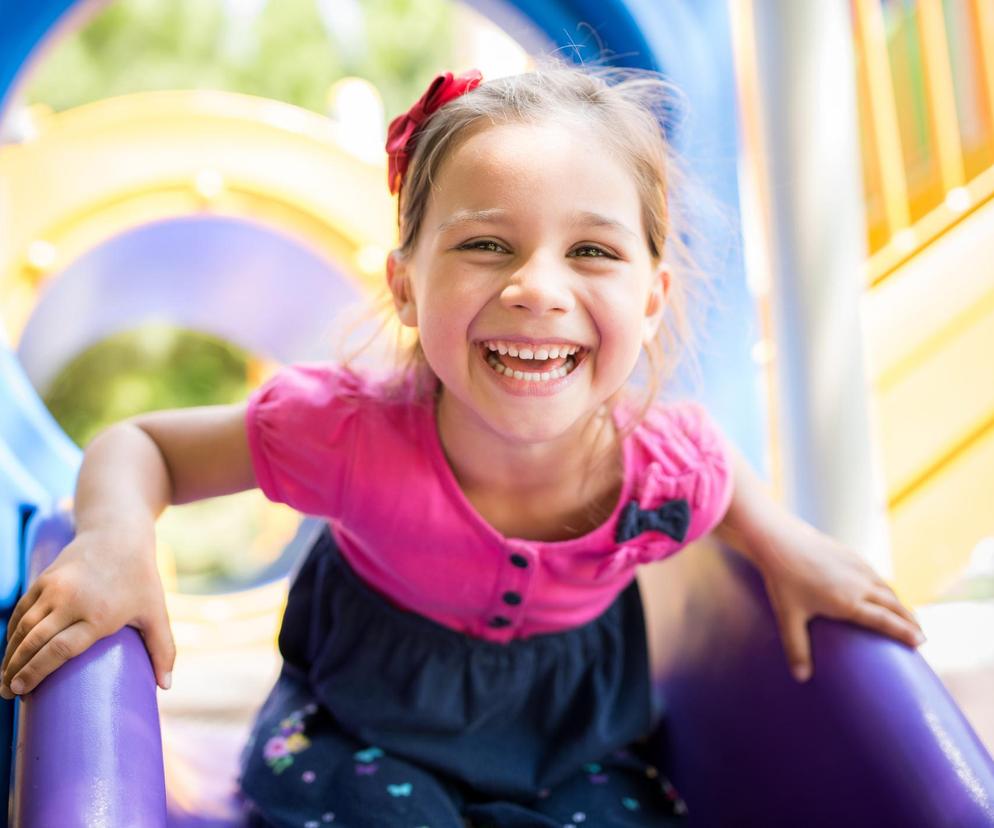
[715,447,925,681]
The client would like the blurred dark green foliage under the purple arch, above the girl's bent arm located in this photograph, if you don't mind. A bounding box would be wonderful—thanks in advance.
[44,324,250,446]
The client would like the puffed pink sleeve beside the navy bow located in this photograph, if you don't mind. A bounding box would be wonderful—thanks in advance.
[636,402,734,551]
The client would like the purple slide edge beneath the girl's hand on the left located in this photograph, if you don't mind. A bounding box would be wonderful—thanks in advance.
[13,515,166,828]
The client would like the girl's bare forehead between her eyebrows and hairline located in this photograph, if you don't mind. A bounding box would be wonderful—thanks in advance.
[428,120,641,230]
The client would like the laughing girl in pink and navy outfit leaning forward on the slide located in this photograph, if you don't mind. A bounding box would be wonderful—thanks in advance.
[2,61,920,828]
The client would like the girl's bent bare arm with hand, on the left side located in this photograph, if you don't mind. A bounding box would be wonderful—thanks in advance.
[0,403,256,699]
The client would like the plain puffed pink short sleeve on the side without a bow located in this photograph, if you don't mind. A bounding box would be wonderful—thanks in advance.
[245,364,364,517]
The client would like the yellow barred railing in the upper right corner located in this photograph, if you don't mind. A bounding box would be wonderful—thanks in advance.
[852,0,994,285]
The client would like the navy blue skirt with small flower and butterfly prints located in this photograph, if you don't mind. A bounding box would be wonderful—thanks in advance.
[240,530,686,828]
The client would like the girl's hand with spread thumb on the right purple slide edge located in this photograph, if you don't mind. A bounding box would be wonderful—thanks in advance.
[760,519,925,682]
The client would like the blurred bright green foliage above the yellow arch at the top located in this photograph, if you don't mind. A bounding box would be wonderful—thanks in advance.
[28,0,453,116]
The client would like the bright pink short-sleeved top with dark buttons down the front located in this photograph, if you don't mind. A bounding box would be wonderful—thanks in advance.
[247,364,732,642]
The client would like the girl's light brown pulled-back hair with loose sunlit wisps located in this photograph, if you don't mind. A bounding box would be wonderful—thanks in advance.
[340,59,710,460]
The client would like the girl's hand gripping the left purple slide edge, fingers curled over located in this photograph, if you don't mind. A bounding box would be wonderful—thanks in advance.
[0,530,176,699]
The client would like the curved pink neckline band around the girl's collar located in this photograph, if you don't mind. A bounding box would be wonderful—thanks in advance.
[422,381,632,549]
